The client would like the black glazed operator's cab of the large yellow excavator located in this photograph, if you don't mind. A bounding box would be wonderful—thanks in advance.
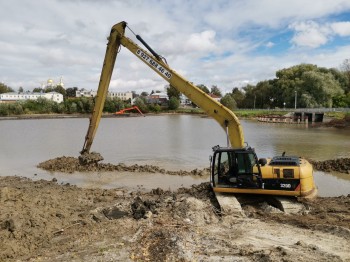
[211,146,262,189]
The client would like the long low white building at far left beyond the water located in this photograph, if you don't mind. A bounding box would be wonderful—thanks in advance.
[0,92,63,103]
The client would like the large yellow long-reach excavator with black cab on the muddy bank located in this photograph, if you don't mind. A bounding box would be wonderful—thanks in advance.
[81,22,316,197]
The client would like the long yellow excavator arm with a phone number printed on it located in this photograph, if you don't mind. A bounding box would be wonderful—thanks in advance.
[81,22,244,154]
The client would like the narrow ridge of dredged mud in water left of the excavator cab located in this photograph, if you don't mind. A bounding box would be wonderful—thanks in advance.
[38,156,209,176]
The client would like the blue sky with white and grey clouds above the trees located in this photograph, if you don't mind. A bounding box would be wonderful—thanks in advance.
[0,0,350,93]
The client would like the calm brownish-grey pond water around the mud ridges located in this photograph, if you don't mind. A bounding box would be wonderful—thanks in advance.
[0,115,350,196]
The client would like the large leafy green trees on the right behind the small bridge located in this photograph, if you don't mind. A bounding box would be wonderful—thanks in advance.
[221,59,350,109]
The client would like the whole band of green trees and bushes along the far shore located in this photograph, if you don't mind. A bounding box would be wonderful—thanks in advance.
[0,59,350,116]
